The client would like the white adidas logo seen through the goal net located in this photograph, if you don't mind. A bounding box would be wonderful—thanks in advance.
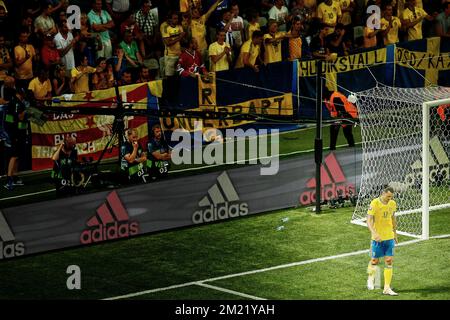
[405,136,450,186]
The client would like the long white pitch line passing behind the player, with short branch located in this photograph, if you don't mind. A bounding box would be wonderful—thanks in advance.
[103,234,450,300]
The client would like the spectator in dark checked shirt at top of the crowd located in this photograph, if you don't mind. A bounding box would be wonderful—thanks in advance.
[135,0,158,57]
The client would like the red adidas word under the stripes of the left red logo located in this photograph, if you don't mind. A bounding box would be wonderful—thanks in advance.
[80,222,139,244]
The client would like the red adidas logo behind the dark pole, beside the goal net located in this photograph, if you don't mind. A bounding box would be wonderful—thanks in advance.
[300,153,356,205]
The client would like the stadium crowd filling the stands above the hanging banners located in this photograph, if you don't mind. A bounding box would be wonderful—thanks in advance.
[0,0,450,190]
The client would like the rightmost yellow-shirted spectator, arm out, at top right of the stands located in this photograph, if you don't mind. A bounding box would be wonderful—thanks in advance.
[401,0,437,41]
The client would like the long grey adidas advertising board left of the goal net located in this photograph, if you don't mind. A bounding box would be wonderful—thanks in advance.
[0,148,362,259]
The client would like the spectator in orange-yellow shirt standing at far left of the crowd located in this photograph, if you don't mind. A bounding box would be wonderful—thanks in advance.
[14,30,38,89]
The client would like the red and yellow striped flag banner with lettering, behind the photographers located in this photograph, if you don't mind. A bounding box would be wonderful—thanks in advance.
[31,81,162,170]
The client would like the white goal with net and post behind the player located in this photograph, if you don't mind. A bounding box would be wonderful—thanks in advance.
[352,86,450,239]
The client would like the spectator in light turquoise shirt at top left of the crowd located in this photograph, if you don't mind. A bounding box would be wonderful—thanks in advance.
[88,0,115,58]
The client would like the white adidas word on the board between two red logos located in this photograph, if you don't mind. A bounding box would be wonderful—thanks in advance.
[192,202,248,224]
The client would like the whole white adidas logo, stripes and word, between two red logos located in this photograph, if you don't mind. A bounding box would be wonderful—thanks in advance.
[192,171,248,224]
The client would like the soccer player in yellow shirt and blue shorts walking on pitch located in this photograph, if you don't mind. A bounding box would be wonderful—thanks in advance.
[367,187,398,296]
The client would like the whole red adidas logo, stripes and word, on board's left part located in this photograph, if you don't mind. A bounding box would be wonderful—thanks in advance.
[80,191,139,244]
